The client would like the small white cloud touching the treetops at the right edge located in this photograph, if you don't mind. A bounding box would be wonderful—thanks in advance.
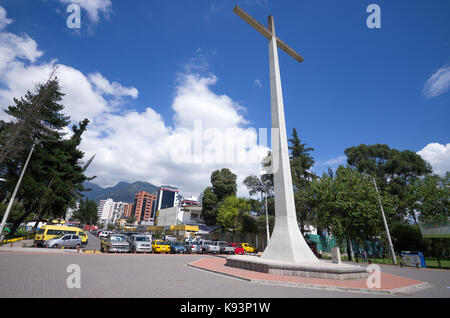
[417,142,450,176]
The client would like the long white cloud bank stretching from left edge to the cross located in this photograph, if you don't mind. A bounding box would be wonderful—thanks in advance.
[0,6,268,195]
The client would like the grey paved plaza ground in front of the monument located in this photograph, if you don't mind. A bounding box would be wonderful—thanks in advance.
[0,249,450,298]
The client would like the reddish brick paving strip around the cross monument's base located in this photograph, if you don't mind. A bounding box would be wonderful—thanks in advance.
[189,257,428,293]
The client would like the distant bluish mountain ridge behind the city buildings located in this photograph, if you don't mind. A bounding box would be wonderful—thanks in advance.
[83,181,158,204]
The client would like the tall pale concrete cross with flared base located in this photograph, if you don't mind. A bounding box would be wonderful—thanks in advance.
[233,6,319,263]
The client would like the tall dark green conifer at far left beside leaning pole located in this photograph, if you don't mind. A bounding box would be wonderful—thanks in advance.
[0,79,89,232]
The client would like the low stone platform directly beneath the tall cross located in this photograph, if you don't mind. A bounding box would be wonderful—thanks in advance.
[225,255,369,280]
